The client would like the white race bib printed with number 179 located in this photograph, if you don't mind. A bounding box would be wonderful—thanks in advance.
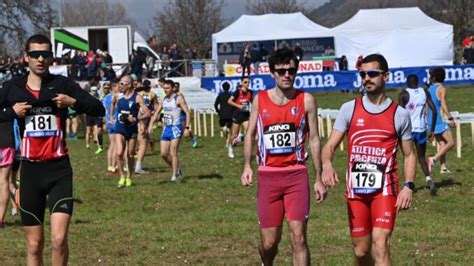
[351,162,383,194]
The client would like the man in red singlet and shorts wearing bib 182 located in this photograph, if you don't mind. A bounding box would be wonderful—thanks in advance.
[240,48,326,265]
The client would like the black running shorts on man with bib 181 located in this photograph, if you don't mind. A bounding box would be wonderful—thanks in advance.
[20,157,74,226]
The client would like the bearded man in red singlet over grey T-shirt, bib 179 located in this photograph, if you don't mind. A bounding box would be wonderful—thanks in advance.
[322,54,416,265]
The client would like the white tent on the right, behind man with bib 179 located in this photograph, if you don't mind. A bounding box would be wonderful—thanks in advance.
[331,7,454,69]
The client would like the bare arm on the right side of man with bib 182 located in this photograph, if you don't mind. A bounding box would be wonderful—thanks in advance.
[304,93,326,202]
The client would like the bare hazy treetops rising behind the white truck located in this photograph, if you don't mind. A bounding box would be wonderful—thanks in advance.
[62,0,134,27]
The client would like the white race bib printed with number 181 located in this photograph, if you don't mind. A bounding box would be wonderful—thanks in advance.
[25,114,58,138]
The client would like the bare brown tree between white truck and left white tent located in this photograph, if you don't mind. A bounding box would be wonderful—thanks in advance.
[153,0,224,56]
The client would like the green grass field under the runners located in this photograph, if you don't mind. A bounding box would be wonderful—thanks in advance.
[0,88,474,265]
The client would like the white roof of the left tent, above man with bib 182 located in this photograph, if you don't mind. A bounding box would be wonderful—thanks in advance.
[212,12,331,60]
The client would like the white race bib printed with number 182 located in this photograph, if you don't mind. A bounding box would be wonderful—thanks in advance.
[263,123,296,155]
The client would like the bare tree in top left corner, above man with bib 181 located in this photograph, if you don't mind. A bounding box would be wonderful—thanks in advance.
[0,0,55,55]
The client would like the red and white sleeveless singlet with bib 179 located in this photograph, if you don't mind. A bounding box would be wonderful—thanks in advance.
[346,97,398,199]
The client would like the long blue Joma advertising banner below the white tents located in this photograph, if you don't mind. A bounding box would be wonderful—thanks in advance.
[201,65,474,93]
